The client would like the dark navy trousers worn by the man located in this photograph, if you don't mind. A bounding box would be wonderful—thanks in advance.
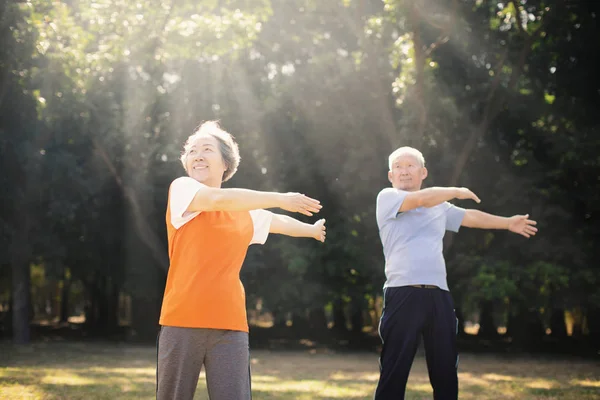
[375,286,458,400]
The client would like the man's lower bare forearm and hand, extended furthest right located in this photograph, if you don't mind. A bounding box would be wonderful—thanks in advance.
[461,210,537,238]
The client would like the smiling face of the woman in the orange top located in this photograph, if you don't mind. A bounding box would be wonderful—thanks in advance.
[185,135,225,187]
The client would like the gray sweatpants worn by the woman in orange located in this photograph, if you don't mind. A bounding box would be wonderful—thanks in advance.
[156,326,252,400]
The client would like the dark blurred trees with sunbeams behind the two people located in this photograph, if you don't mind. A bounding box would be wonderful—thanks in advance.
[0,0,600,355]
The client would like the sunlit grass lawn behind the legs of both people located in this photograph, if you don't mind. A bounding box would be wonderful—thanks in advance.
[0,342,600,400]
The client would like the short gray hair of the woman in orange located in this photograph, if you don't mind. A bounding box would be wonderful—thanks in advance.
[180,121,240,182]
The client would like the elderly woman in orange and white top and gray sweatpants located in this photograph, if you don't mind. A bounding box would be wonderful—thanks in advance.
[156,121,325,400]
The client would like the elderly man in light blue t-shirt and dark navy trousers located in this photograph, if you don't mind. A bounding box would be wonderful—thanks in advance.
[375,147,537,400]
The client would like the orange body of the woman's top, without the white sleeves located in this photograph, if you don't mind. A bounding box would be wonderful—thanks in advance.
[160,191,254,332]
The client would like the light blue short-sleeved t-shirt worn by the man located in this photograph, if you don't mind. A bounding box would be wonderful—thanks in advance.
[376,188,465,290]
